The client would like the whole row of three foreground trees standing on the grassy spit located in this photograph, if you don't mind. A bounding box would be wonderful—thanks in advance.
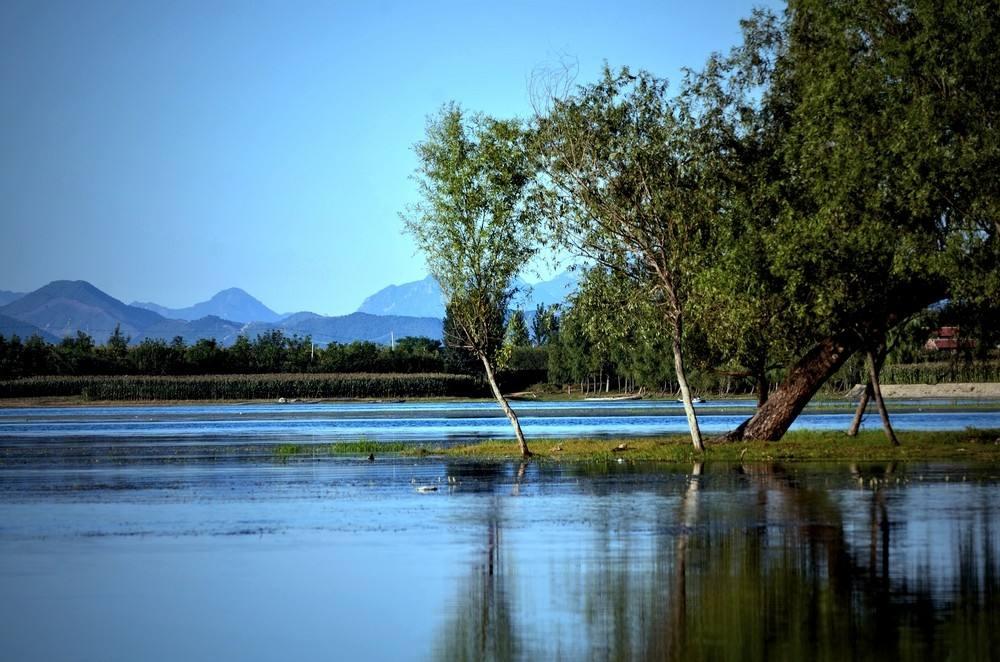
[403,0,1000,455]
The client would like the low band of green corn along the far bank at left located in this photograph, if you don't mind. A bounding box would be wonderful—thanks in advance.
[0,373,483,401]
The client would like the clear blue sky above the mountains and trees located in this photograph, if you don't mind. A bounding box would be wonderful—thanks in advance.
[0,0,778,314]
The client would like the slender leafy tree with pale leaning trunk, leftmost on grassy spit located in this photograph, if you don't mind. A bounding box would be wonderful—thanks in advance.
[401,104,538,456]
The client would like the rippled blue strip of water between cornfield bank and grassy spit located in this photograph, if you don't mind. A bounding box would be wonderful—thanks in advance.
[0,400,1000,444]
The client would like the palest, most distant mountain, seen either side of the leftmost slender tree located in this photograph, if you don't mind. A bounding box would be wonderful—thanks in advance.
[358,271,578,318]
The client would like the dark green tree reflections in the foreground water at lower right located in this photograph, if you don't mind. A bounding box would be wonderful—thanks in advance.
[435,464,1000,660]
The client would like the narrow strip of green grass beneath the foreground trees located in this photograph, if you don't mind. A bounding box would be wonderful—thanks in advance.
[441,430,1000,462]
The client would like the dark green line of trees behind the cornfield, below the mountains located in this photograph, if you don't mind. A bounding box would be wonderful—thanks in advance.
[0,328,454,378]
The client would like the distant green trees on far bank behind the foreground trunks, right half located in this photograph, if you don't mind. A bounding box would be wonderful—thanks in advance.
[544,282,1000,396]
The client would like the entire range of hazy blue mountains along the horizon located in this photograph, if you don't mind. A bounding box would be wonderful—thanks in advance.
[0,274,576,345]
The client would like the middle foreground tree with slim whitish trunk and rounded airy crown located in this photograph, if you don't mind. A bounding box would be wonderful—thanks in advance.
[537,69,716,450]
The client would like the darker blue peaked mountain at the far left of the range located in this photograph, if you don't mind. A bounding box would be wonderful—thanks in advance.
[0,280,163,343]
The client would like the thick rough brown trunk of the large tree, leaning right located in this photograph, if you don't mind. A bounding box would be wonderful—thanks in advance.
[726,331,861,441]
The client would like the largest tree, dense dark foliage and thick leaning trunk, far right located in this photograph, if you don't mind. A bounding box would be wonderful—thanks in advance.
[729,0,1000,440]
